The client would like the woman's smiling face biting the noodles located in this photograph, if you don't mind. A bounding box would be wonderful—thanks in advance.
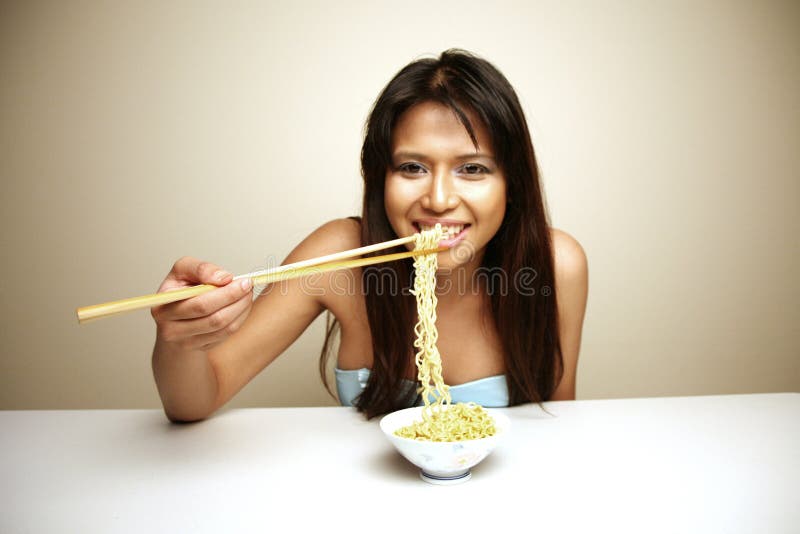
[384,102,506,269]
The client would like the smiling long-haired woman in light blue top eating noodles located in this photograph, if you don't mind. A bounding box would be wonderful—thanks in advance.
[152,50,588,421]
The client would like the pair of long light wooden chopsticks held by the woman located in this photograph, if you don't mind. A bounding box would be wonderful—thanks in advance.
[75,235,448,324]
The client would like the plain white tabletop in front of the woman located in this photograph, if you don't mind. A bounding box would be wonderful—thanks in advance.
[0,393,800,534]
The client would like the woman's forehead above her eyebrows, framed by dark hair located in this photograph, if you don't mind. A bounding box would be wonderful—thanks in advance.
[392,102,491,153]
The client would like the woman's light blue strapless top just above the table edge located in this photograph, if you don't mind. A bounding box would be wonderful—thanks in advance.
[334,367,508,408]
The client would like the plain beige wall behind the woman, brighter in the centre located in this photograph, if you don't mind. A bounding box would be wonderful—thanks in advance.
[0,1,800,409]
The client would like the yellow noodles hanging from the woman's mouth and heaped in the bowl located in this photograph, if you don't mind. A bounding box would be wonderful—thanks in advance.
[395,224,496,441]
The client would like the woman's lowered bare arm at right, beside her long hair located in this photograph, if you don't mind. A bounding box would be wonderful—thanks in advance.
[549,229,589,400]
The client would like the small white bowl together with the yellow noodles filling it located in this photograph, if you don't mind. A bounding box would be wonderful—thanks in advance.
[380,403,511,485]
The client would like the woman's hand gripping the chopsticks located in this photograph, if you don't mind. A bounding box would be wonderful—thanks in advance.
[150,256,253,352]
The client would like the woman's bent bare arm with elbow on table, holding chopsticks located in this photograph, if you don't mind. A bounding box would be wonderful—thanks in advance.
[153,219,360,421]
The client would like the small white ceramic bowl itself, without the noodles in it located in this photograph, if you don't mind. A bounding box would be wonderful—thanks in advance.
[381,406,511,484]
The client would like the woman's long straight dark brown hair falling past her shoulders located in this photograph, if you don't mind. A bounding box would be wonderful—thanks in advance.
[320,49,563,418]
